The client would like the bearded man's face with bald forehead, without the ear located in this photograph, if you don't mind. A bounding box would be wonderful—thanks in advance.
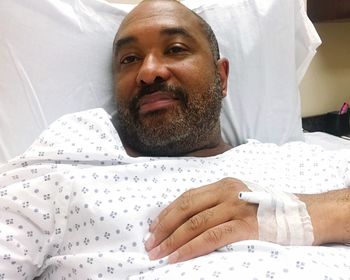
[114,1,223,156]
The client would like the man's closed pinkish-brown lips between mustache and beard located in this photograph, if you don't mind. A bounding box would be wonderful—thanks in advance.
[139,91,178,114]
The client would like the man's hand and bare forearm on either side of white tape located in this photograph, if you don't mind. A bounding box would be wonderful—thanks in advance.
[145,175,350,263]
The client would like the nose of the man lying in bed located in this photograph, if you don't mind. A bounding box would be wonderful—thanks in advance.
[136,55,170,85]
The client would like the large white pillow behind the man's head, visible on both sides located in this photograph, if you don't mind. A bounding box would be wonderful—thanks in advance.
[0,0,319,162]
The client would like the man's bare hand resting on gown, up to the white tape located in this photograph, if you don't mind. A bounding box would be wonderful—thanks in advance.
[145,178,258,263]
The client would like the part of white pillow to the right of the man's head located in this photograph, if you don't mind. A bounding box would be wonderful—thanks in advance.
[190,0,320,149]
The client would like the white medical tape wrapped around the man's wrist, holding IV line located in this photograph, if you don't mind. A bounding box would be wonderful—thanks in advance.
[239,181,314,245]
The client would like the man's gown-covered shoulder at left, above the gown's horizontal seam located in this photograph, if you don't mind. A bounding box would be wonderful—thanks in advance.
[11,108,124,166]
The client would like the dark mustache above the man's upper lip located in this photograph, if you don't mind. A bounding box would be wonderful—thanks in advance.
[130,82,188,113]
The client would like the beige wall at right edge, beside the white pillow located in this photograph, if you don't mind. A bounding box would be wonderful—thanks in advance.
[300,21,350,116]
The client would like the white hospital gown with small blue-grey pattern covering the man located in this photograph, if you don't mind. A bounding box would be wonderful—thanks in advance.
[0,109,350,280]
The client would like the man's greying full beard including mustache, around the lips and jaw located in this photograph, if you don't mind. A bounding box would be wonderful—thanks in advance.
[115,73,223,156]
